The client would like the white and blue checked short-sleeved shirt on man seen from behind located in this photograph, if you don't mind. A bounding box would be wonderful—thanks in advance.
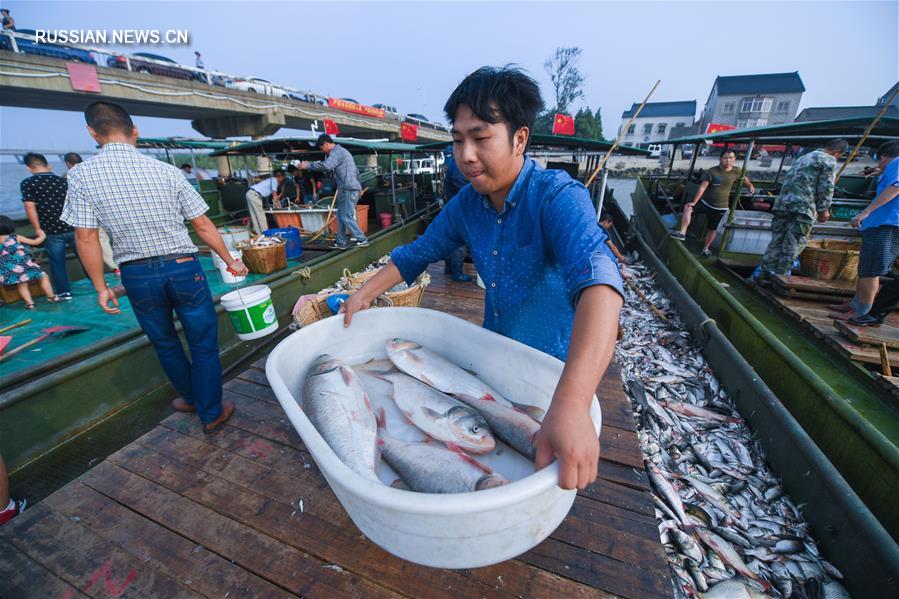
[61,143,209,264]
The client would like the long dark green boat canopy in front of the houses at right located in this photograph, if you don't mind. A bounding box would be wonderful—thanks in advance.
[656,116,899,146]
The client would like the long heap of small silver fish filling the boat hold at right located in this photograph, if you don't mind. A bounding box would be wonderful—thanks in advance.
[616,255,849,599]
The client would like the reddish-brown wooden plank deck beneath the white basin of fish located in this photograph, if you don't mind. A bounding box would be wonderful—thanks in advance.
[0,265,671,599]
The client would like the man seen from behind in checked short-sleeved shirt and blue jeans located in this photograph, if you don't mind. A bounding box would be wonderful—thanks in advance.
[62,102,247,433]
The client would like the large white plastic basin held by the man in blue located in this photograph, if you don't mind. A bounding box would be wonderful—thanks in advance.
[265,308,602,568]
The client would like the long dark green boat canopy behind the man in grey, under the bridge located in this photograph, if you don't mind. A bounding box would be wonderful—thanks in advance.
[212,137,428,159]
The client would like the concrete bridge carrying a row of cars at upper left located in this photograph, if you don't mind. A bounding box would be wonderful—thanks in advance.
[0,51,450,142]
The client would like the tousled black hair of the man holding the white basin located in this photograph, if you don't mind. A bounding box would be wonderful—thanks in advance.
[443,65,543,149]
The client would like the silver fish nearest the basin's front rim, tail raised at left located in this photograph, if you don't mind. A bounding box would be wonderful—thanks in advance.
[378,417,509,493]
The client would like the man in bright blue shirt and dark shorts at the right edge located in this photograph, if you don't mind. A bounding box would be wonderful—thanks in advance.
[829,141,899,324]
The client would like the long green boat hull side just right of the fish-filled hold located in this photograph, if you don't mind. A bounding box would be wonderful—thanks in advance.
[632,181,899,539]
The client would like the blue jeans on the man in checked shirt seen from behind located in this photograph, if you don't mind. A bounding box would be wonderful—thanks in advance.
[120,256,222,423]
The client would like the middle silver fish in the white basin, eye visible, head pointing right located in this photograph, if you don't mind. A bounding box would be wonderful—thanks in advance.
[383,372,496,453]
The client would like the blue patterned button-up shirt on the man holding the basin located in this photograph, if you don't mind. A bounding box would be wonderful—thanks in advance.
[391,158,624,360]
